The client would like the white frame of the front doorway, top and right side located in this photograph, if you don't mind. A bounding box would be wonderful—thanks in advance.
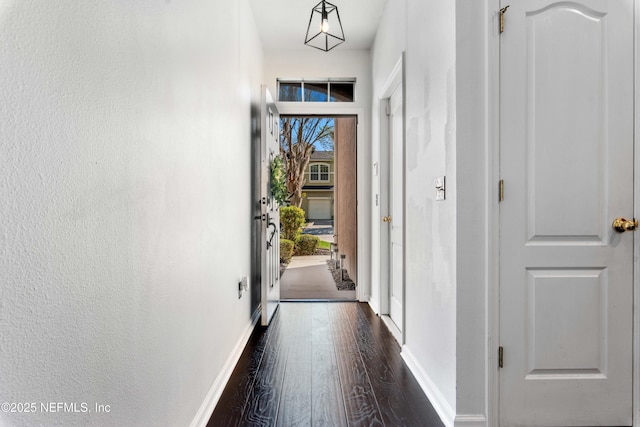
[276,101,364,302]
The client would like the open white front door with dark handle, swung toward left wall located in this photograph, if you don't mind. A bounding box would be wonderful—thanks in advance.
[260,86,280,326]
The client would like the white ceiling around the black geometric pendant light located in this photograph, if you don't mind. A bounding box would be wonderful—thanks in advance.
[249,0,387,50]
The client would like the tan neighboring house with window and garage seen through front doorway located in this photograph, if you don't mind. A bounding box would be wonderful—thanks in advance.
[301,151,335,220]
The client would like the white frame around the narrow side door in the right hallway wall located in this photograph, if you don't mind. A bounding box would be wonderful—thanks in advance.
[372,52,406,346]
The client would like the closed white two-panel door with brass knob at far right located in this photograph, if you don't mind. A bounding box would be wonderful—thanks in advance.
[500,0,634,426]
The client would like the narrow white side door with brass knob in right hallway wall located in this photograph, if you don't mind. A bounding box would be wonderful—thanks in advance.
[386,86,404,331]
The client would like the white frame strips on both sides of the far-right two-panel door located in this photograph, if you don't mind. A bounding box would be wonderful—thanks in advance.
[485,0,640,425]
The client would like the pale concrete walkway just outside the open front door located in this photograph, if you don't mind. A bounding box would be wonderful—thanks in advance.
[280,255,356,300]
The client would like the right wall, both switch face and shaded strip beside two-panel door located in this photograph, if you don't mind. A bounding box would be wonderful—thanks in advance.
[372,0,489,425]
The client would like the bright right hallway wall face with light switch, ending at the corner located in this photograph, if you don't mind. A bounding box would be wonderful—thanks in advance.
[373,0,456,422]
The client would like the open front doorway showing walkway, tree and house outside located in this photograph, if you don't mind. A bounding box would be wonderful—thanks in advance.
[281,115,358,300]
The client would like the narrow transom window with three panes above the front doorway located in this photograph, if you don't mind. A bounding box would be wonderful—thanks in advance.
[278,79,356,102]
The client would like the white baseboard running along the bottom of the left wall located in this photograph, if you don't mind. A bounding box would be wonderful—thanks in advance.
[190,310,260,427]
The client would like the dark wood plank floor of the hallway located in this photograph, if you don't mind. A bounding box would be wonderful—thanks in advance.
[208,302,443,427]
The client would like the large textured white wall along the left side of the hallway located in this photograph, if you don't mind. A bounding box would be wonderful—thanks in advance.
[0,0,262,426]
